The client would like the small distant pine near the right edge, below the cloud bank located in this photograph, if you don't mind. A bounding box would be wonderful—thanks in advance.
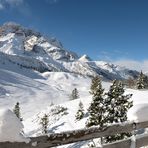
[136,71,145,89]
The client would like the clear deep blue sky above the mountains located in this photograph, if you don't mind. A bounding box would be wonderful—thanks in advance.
[0,0,148,70]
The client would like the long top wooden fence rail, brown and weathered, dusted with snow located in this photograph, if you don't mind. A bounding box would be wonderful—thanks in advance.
[28,121,148,147]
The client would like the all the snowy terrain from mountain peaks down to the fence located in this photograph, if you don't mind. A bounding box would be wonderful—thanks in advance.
[0,24,145,148]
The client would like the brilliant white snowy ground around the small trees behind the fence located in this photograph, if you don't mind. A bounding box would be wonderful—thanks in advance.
[24,86,148,136]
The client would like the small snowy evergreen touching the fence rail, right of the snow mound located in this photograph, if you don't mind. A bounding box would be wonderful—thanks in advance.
[40,114,49,134]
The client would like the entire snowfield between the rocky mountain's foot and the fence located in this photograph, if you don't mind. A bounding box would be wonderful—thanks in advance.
[0,63,148,148]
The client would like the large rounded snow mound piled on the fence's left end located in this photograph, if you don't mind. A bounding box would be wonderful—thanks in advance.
[0,109,29,143]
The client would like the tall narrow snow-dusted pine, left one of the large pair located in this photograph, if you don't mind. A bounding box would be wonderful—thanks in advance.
[86,76,106,128]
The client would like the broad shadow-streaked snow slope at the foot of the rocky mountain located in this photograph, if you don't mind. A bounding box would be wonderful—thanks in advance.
[0,57,90,118]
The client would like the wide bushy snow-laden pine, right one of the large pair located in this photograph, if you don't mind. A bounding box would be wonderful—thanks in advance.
[104,80,133,143]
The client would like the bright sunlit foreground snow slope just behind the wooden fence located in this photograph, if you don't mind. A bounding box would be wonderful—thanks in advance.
[23,82,148,148]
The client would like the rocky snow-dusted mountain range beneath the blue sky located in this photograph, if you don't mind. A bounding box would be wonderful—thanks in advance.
[0,23,139,80]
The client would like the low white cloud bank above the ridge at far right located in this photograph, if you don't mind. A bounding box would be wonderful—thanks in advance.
[112,59,148,72]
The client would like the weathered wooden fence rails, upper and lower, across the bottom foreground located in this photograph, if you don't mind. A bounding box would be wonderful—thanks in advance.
[0,121,148,148]
